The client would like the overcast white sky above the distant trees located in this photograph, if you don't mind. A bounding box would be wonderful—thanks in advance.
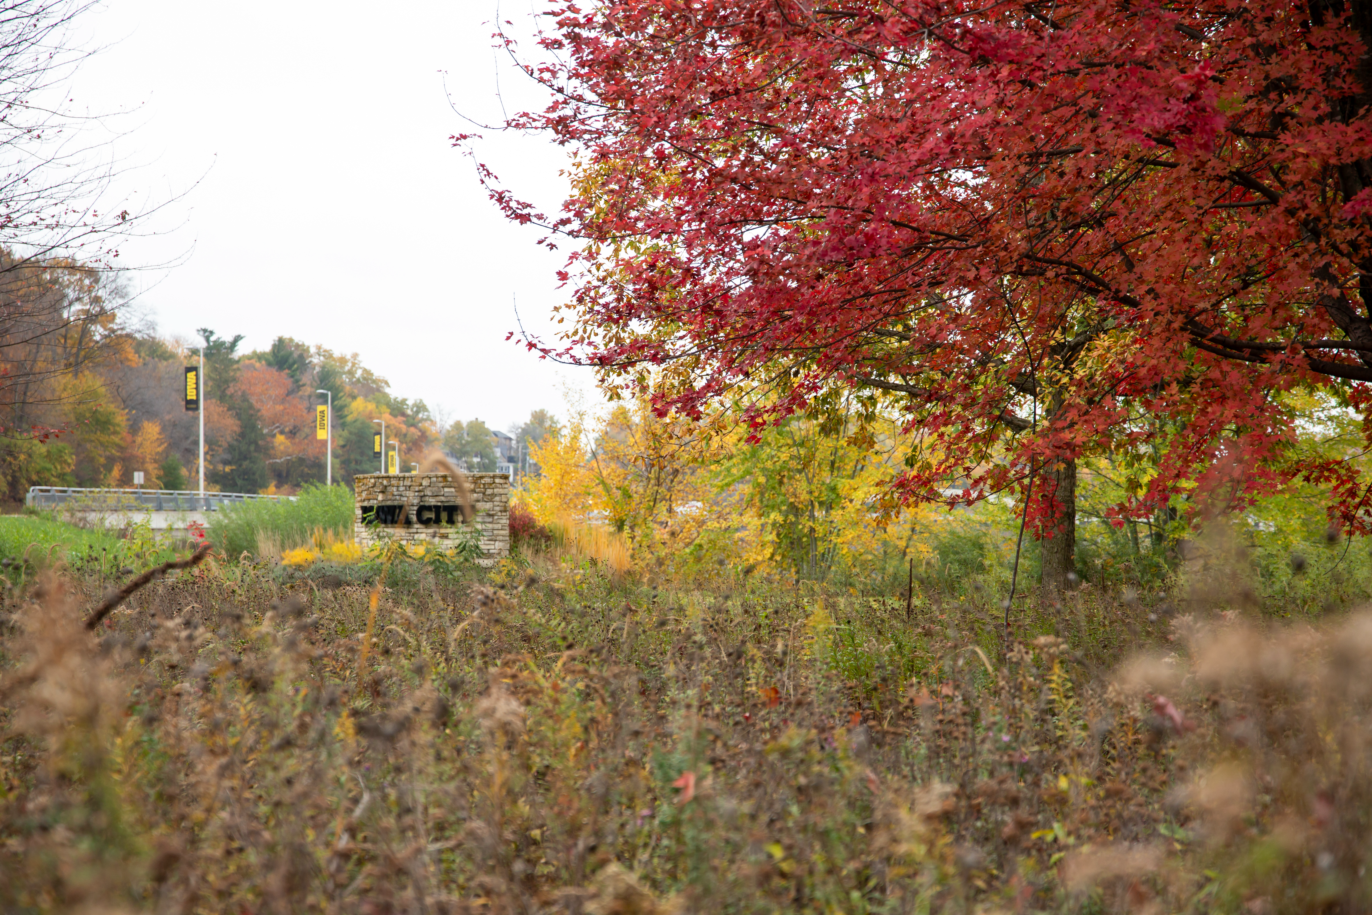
[70,0,593,428]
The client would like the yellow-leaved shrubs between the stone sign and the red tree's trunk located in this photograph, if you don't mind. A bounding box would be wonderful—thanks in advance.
[517,386,993,582]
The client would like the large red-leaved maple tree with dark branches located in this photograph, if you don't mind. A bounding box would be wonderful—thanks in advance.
[469,0,1372,587]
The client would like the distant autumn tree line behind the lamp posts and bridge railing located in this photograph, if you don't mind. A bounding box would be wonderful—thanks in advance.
[0,286,557,501]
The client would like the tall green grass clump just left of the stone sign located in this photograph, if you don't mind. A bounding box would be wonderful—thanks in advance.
[210,484,354,558]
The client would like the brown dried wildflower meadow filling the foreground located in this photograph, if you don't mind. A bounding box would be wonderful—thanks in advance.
[0,540,1372,914]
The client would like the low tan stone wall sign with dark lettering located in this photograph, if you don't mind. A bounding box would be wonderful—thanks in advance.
[353,473,510,565]
